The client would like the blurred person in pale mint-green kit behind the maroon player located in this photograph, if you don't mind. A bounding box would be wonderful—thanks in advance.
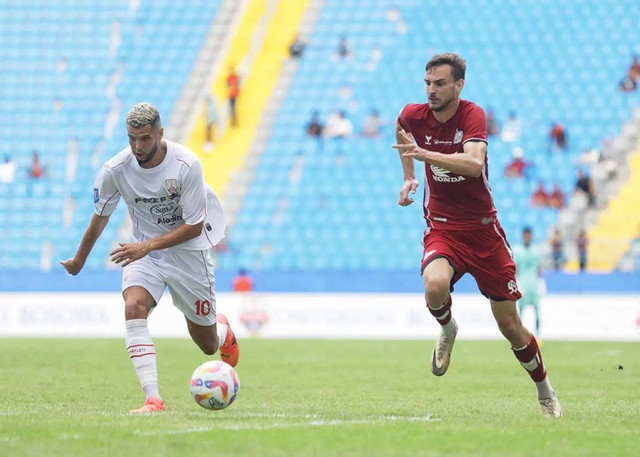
[513,227,542,336]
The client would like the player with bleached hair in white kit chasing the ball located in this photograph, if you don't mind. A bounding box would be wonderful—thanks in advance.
[60,103,239,413]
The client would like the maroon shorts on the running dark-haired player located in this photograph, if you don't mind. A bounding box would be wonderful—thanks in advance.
[421,222,522,301]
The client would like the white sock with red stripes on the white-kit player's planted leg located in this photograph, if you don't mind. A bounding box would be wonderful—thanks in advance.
[125,319,161,399]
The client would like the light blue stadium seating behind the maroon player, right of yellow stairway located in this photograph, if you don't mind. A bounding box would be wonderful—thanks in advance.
[220,0,638,270]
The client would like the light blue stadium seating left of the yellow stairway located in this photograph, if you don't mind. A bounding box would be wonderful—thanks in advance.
[0,0,221,269]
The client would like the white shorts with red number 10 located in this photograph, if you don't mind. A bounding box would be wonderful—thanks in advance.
[122,249,216,326]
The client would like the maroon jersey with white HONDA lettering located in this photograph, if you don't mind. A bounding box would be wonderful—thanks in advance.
[398,100,496,230]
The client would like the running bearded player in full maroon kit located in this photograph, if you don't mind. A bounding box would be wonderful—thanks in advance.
[393,54,562,417]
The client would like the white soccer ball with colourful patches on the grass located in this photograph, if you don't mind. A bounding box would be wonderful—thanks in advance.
[189,360,240,409]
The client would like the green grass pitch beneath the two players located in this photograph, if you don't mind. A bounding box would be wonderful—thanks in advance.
[0,339,640,457]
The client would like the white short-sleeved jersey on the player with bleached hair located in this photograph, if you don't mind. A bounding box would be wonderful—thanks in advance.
[93,140,224,250]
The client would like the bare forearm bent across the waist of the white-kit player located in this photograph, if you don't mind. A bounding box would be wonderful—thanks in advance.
[110,222,203,267]
